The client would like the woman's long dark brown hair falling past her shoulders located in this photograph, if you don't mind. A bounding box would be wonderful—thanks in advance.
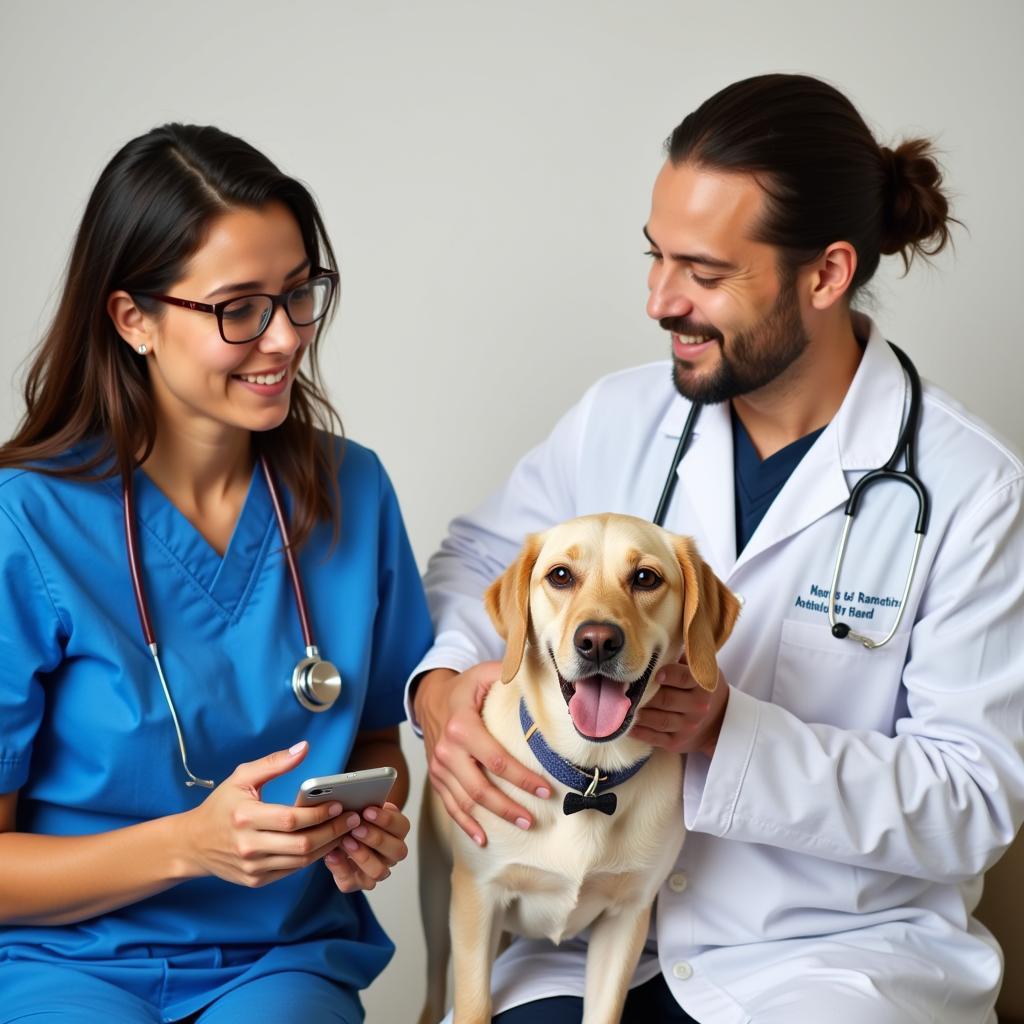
[0,124,341,547]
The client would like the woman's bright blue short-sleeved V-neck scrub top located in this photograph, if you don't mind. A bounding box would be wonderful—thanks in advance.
[0,441,432,1019]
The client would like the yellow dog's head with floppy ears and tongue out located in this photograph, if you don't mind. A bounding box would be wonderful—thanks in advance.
[484,515,739,742]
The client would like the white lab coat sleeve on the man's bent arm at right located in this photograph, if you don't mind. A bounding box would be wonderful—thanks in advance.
[684,478,1024,883]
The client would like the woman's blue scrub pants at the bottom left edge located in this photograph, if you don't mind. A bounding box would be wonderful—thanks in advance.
[0,964,362,1024]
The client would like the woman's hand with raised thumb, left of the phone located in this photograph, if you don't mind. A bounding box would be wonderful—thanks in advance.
[181,741,362,888]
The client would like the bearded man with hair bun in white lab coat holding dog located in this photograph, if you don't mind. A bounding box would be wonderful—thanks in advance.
[410,76,1024,1024]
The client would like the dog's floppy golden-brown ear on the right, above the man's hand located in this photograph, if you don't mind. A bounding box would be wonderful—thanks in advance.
[676,537,739,690]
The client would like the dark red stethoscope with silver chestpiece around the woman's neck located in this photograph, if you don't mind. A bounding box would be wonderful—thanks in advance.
[121,455,341,790]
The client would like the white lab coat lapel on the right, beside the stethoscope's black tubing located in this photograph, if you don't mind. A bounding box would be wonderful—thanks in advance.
[735,315,906,569]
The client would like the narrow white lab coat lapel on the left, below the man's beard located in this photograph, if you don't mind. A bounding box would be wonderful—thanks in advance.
[672,399,736,579]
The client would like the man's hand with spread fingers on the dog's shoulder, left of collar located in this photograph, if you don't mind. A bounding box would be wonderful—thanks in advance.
[416,662,551,846]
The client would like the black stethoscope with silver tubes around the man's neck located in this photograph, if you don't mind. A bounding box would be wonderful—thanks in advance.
[653,342,931,650]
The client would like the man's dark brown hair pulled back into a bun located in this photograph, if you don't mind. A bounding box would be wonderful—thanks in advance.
[665,75,958,296]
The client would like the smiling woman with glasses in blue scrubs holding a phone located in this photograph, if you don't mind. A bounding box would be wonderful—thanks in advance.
[0,125,431,1024]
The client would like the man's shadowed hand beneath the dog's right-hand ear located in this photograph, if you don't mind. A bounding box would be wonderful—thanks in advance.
[630,659,729,758]
